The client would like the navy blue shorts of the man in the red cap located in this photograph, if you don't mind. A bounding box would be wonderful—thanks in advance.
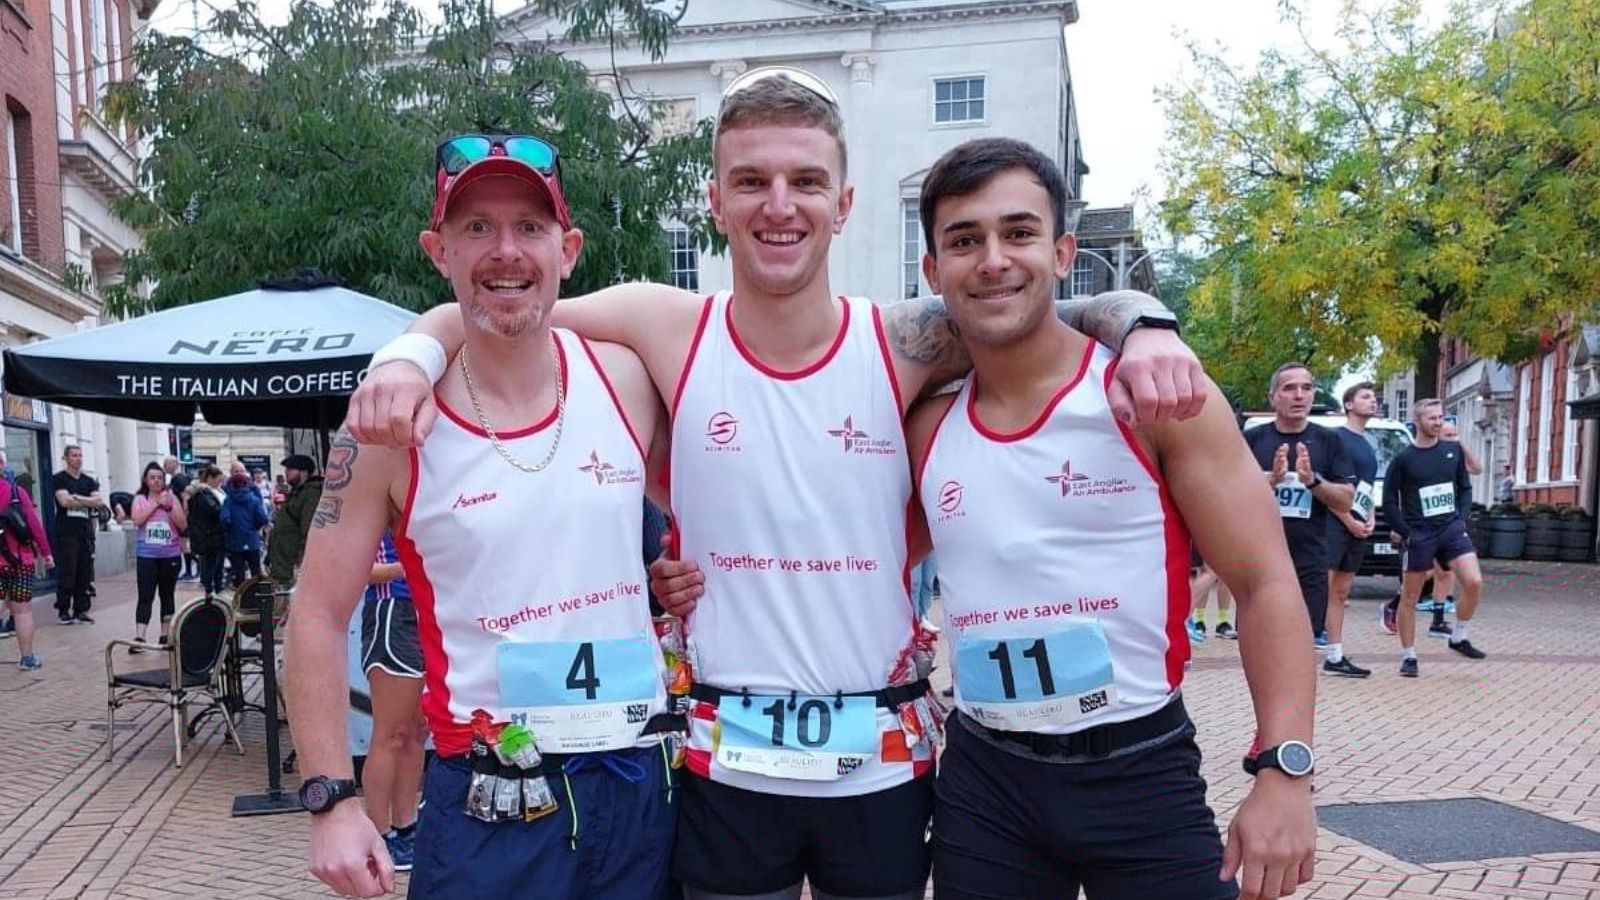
[406,749,678,900]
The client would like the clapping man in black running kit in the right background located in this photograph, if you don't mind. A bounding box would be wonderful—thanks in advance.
[1245,362,1355,647]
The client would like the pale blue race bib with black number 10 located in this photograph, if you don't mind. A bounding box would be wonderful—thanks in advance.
[712,695,880,781]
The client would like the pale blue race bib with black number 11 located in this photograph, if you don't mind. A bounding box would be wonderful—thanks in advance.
[955,621,1117,732]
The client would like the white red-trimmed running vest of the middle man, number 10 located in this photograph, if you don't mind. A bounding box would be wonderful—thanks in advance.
[670,293,930,796]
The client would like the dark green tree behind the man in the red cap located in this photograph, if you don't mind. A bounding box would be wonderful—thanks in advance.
[109,0,710,314]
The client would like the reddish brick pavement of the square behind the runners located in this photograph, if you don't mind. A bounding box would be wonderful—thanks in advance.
[0,560,1600,900]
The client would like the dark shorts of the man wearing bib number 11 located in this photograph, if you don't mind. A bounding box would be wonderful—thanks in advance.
[933,714,1238,900]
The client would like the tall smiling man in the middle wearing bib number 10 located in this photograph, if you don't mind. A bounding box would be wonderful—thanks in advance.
[350,69,1198,900]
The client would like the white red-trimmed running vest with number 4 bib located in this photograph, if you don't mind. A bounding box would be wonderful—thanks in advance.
[395,330,667,756]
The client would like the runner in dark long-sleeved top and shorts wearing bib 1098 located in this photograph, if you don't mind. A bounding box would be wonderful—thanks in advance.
[1384,393,1485,677]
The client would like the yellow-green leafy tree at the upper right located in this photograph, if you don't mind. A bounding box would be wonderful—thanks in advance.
[1163,0,1600,397]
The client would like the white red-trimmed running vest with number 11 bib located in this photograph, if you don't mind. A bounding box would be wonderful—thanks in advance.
[918,343,1189,735]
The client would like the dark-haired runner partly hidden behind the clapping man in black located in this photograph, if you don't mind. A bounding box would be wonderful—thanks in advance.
[1322,381,1378,677]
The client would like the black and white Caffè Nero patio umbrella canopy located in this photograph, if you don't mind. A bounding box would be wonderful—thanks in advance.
[5,277,416,429]
